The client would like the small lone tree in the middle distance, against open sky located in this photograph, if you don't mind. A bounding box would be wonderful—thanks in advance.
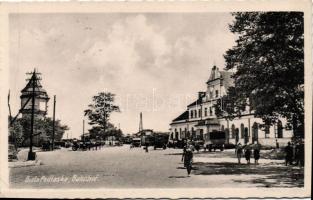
[84,92,120,136]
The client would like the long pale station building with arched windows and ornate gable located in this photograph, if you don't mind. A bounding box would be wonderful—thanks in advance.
[170,66,293,145]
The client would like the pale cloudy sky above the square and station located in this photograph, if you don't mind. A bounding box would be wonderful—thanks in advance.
[9,13,236,137]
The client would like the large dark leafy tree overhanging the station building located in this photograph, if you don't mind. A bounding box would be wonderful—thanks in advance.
[219,12,304,136]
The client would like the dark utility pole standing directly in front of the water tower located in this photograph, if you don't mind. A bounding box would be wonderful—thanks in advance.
[28,70,36,160]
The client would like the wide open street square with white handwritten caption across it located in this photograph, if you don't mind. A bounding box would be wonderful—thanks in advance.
[10,145,304,188]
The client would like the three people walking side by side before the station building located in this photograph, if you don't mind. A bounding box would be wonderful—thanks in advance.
[235,143,260,165]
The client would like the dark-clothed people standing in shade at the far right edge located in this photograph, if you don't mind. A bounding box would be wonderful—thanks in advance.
[285,140,304,167]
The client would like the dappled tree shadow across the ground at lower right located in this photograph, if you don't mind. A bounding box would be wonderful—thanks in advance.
[193,162,304,187]
